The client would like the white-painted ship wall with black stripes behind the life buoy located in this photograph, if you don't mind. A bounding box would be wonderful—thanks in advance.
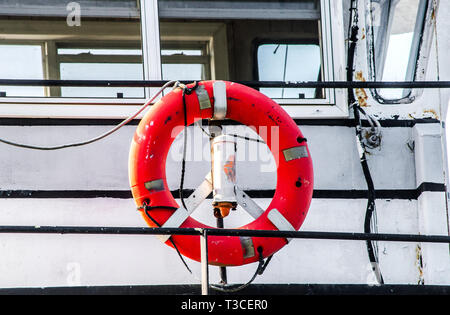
[0,123,449,287]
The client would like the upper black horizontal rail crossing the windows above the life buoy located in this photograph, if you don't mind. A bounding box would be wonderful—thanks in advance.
[0,79,450,89]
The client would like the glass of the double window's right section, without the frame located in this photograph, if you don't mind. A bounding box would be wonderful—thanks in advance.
[158,0,323,99]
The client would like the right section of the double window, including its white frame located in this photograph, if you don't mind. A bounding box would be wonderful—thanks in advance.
[158,0,347,117]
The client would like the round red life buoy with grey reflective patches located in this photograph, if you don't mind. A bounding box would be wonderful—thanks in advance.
[129,81,313,266]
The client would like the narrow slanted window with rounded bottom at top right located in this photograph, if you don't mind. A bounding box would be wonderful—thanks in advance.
[368,0,432,104]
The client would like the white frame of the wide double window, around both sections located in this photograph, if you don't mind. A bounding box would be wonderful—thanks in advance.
[0,0,349,119]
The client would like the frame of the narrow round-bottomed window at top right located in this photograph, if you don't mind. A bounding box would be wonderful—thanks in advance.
[365,0,434,105]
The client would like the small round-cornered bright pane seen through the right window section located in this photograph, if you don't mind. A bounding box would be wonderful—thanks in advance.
[258,44,321,99]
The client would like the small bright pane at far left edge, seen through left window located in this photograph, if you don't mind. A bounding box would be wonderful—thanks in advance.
[0,45,44,97]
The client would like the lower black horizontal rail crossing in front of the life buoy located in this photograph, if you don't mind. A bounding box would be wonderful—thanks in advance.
[0,226,450,244]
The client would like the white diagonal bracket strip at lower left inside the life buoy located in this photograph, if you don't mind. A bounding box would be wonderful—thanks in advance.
[158,173,212,243]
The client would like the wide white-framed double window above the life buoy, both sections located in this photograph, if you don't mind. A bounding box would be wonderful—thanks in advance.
[0,0,348,118]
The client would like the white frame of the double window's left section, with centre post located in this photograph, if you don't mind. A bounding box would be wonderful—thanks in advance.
[0,0,153,119]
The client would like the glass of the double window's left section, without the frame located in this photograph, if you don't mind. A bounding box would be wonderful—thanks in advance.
[0,0,145,98]
